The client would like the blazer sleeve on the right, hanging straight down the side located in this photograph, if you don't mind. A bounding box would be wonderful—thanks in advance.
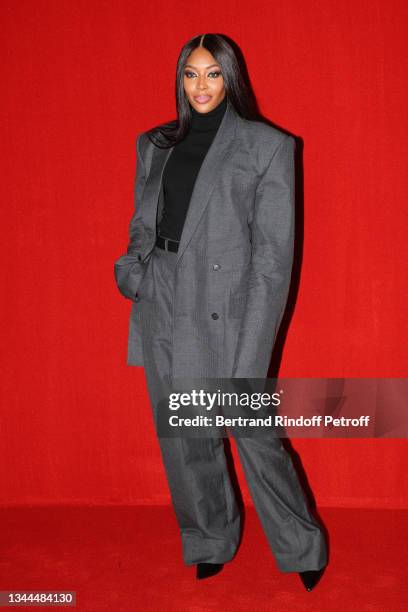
[232,134,296,378]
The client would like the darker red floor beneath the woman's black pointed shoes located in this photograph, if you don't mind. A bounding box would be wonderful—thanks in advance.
[0,506,408,612]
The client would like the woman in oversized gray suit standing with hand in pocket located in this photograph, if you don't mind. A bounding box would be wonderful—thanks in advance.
[115,34,327,590]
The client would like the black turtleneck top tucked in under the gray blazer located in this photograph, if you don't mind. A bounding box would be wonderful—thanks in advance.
[159,96,227,240]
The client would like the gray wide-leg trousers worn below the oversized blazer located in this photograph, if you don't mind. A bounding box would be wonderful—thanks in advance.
[138,246,327,572]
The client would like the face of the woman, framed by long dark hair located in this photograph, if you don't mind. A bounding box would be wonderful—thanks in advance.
[183,47,226,113]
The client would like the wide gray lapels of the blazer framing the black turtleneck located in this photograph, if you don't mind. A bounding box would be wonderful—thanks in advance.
[143,102,238,261]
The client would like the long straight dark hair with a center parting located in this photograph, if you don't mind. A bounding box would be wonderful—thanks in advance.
[146,34,262,148]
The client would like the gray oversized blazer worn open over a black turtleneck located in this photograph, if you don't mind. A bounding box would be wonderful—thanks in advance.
[114,100,296,378]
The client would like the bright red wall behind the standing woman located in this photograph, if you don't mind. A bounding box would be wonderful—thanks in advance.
[0,0,408,507]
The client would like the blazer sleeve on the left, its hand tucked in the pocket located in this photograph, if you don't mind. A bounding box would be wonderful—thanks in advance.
[114,134,146,300]
